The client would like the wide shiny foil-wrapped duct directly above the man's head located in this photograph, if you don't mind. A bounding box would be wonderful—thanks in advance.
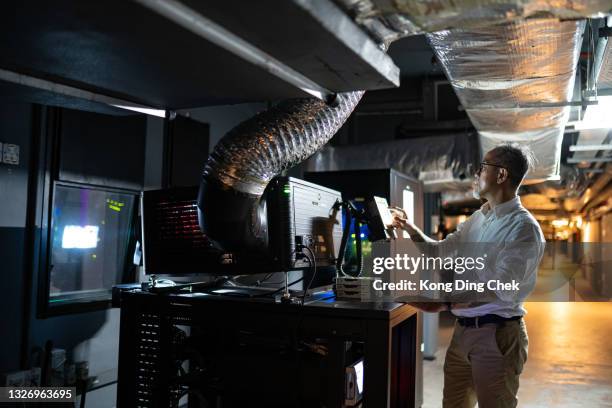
[427,18,584,180]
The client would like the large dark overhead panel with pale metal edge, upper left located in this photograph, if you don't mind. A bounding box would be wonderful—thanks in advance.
[0,0,399,109]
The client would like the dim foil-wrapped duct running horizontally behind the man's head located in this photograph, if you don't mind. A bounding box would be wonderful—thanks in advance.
[305,133,479,191]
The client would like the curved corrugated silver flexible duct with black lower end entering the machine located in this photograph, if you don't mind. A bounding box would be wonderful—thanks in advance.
[198,91,363,250]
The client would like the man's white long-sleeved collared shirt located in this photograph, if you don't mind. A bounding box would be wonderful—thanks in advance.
[436,196,546,317]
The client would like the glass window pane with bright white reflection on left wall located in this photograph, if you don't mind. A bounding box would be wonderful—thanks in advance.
[49,185,135,304]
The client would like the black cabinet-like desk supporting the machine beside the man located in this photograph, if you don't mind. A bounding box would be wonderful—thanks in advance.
[117,290,422,408]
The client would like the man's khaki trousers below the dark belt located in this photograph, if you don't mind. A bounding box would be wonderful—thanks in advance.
[442,319,529,408]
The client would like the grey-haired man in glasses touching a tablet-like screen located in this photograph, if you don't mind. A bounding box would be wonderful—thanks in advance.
[395,144,545,408]
